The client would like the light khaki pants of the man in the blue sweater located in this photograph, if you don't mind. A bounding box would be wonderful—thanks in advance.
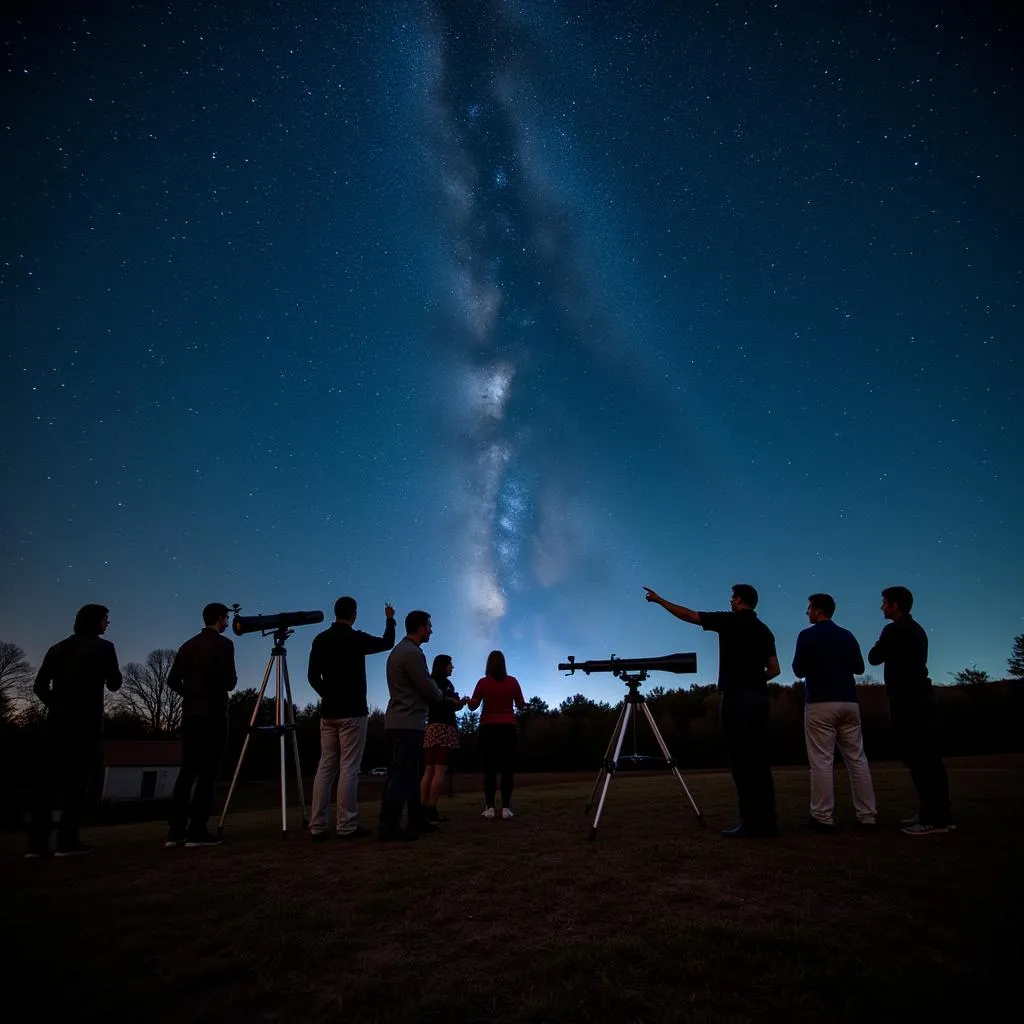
[804,700,876,825]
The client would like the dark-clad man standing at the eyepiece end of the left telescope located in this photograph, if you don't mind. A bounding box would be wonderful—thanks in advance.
[164,602,239,847]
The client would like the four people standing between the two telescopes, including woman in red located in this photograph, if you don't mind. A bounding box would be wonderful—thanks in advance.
[307,597,525,843]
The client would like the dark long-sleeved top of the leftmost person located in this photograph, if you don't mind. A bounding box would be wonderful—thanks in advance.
[32,633,121,730]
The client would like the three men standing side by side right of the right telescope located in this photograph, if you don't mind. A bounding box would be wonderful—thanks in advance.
[644,584,955,839]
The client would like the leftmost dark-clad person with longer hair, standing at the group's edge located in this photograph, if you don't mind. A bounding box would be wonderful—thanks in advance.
[26,604,121,858]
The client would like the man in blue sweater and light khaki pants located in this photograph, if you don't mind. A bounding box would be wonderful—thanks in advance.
[793,594,876,833]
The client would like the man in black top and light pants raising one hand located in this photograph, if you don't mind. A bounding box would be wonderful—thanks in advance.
[308,597,394,843]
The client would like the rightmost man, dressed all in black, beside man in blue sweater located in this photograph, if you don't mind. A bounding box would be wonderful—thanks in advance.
[867,587,955,836]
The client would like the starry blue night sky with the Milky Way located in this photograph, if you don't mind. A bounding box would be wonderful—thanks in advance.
[0,0,1024,705]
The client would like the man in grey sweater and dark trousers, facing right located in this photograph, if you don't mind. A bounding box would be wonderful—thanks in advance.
[378,611,443,841]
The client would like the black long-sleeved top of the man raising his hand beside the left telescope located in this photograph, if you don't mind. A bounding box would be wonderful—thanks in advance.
[307,618,394,718]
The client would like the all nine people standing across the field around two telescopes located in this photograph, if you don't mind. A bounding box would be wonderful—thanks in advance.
[26,584,954,858]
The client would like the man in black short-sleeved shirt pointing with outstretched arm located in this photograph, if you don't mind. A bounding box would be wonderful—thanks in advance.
[644,583,780,839]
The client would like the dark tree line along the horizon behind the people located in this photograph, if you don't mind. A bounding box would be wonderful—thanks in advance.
[0,634,1024,794]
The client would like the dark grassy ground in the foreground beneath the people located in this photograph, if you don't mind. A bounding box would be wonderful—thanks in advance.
[0,760,1024,1024]
